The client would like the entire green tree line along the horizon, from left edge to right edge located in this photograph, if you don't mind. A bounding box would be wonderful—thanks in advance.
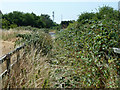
[0,6,120,29]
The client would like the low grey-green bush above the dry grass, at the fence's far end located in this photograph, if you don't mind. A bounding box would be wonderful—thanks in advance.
[16,31,52,55]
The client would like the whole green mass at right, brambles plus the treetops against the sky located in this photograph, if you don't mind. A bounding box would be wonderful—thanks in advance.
[50,6,120,88]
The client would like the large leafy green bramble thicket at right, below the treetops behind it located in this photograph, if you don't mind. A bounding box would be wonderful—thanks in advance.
[51,20,120,88]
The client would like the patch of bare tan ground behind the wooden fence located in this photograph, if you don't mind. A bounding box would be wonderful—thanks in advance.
[0,40,14,57]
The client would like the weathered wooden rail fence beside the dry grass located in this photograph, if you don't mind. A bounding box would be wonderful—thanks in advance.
[0,44,25,86]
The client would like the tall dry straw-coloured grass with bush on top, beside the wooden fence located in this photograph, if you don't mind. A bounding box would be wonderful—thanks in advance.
[3,31,52,88]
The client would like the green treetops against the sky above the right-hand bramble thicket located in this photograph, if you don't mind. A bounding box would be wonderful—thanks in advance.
[77,5,120,24]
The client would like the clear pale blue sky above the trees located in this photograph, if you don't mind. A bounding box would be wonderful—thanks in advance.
[0,0,119,23]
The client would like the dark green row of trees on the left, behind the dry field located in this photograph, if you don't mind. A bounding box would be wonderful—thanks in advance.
[2,11,55,29]
